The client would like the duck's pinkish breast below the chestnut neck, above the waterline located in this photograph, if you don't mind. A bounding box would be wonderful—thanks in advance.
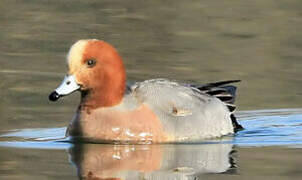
[71,105,166,143]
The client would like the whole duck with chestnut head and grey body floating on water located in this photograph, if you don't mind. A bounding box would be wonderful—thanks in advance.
[49,39,243,144]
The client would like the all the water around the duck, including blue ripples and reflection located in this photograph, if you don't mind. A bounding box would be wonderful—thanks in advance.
[0,0,302,180]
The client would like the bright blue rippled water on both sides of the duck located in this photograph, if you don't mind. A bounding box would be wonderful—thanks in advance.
[0,109,302,149]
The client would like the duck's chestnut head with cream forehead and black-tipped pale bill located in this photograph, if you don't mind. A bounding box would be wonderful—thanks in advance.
[49,39,126,107]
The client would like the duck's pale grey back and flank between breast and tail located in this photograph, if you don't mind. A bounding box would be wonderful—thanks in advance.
[130,79,234,142]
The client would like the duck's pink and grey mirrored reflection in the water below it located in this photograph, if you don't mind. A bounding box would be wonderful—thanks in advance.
[69,144,235,180]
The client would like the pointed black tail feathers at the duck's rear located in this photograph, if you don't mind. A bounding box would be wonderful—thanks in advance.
[194,80,243,132]
